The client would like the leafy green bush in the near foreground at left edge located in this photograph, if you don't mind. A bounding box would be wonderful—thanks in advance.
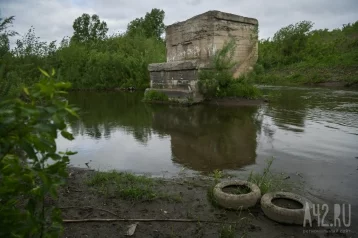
[0,70,77,237]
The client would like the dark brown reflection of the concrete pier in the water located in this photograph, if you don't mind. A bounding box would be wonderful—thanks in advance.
[153,106,257,172]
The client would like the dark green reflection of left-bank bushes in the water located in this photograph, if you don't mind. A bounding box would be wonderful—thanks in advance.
[68,92,151,144]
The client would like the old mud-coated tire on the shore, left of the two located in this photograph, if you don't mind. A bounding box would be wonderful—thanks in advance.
[213,180,261,209]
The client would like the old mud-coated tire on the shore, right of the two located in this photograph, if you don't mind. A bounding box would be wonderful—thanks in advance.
[261,192,313,225]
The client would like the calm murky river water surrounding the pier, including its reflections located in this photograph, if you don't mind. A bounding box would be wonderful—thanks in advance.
[57,87,358,229]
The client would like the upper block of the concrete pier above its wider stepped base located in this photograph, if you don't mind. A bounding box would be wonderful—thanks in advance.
[166,11,258,76]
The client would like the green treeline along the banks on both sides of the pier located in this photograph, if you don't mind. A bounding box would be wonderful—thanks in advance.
[0,9,358,96]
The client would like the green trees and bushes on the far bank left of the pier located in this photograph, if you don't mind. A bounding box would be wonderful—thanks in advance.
[0,9,166,97]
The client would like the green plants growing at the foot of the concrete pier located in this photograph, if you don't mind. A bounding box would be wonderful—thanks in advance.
[198,40,261,99]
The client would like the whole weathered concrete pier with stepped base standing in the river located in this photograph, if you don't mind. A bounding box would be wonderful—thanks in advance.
[148,11,258,100]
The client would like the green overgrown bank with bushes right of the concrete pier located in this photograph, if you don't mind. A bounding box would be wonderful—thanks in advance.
[250,21,358,85]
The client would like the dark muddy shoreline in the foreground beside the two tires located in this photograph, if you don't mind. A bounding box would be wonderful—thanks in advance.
[55,168,353,237]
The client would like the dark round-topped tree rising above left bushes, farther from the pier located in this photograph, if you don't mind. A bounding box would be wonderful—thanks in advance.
[72,13,108,42]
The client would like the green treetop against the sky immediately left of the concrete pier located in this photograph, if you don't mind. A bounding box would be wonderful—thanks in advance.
[127,8,165,40]
